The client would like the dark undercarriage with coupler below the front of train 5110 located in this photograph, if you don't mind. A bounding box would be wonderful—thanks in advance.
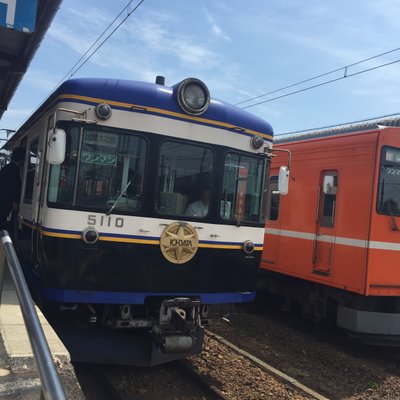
[35,290,208,366]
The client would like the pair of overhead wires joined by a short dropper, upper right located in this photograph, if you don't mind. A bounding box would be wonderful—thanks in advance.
[235,47,400,109]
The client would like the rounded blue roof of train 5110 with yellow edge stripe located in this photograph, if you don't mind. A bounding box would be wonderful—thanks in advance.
[13,78,273,141]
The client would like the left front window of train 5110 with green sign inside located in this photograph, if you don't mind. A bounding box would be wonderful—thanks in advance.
[76,130,146,211]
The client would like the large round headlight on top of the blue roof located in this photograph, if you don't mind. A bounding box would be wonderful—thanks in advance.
[178,78,210,115]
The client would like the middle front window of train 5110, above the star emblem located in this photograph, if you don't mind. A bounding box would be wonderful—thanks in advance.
[155,141,214,218]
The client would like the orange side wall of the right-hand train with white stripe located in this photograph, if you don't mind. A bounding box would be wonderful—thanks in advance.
[261,131,378,293]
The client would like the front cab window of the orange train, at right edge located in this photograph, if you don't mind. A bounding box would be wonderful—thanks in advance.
[377,146,400,217]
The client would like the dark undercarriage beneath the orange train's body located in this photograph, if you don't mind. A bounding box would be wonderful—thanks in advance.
[258,271,400,347]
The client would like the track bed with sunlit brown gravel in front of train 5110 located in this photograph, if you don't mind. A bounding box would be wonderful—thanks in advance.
[75,331,328,400]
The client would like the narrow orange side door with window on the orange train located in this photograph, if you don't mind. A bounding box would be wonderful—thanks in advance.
[313,171,338,276]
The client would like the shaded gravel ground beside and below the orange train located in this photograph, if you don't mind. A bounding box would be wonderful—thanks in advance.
[210,305,400,400]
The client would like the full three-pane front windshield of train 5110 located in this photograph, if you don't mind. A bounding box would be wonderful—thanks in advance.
[48,127,265,223]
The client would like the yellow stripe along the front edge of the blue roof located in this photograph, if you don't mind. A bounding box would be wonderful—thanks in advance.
[59,94,272,140]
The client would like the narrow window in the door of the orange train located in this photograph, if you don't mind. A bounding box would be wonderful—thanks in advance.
[320,172,338,227]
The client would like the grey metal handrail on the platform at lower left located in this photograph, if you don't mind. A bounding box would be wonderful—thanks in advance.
[0,230,66,400]
